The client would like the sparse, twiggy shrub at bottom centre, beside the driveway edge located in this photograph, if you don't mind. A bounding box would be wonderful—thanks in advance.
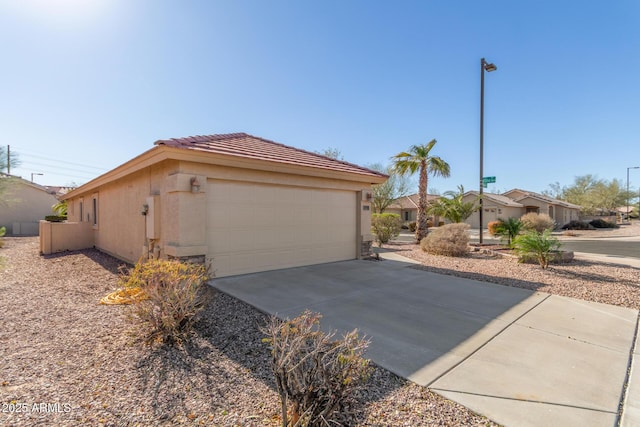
[263,310,370,427]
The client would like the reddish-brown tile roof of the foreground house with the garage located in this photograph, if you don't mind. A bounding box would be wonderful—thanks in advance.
[154,133,387,178]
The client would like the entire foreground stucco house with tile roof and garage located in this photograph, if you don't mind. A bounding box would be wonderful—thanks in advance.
[47,133,387,277]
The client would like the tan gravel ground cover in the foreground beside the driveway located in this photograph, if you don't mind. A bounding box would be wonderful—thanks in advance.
[0,238,496,426]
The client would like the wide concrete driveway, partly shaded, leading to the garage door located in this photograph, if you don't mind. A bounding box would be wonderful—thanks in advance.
[212,260,640,426]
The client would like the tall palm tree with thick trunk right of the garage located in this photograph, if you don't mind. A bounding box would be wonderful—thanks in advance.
[392,139,450,242]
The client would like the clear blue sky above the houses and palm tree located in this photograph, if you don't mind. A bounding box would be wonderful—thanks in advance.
[0,0,640,196]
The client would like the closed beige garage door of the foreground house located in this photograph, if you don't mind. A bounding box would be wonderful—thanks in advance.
[207,181,356,277]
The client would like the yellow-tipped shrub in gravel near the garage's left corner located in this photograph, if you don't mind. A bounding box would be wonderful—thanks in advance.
[125,260,209,343]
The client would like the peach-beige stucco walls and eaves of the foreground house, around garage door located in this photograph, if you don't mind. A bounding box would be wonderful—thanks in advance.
[62,155,378,262]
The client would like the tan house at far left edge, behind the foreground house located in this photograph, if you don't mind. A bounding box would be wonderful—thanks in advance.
[0,173,58,236]
